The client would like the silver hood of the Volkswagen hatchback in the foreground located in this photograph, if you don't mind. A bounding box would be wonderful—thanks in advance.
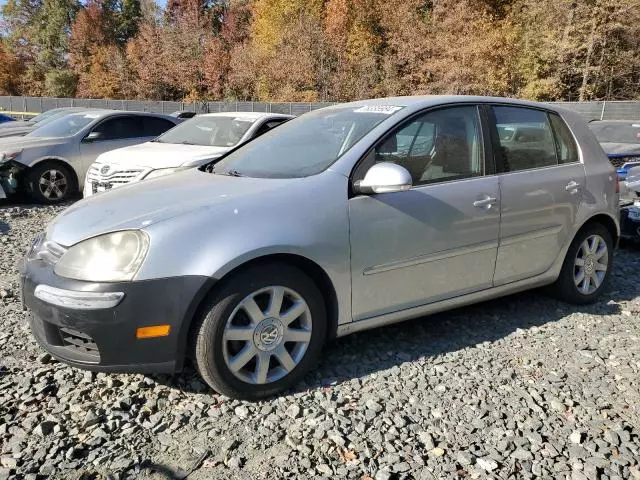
[47,169,304,246]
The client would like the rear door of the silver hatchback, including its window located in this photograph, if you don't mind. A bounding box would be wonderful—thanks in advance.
[487,105,585,285]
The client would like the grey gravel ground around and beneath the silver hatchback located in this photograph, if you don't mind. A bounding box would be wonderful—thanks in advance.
[0,202,640,480]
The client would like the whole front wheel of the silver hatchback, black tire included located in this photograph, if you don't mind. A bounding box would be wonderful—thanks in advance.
[192,264,327,400]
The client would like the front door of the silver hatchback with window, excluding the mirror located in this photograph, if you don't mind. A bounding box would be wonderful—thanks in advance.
[349,106,500,320]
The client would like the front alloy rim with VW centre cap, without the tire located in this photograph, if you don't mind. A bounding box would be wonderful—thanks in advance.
[222,286,312,384]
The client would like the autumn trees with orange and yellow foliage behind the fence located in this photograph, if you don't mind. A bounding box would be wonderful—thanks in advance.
[0,0,640,101]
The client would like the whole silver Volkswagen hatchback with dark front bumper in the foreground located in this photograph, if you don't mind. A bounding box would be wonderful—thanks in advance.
[21,96,619,399]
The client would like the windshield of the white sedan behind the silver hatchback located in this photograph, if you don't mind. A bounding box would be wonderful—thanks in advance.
[154,115,256,147]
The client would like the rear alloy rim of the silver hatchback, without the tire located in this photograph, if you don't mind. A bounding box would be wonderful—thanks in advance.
[573,235,609,295]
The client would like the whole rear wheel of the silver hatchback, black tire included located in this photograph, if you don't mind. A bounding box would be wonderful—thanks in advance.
[552,223,615,305]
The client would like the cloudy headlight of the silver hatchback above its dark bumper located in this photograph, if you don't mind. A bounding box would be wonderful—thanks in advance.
[54,230,149,282]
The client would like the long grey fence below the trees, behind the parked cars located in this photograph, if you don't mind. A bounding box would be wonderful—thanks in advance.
[0,96,640,121]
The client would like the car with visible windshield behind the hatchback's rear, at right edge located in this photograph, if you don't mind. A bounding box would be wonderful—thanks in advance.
[589,120,640,180]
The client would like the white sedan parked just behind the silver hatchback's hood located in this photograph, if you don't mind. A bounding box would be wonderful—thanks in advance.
[83,112,293,197]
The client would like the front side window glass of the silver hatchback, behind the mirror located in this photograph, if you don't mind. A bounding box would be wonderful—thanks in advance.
[356,106,484,186]
